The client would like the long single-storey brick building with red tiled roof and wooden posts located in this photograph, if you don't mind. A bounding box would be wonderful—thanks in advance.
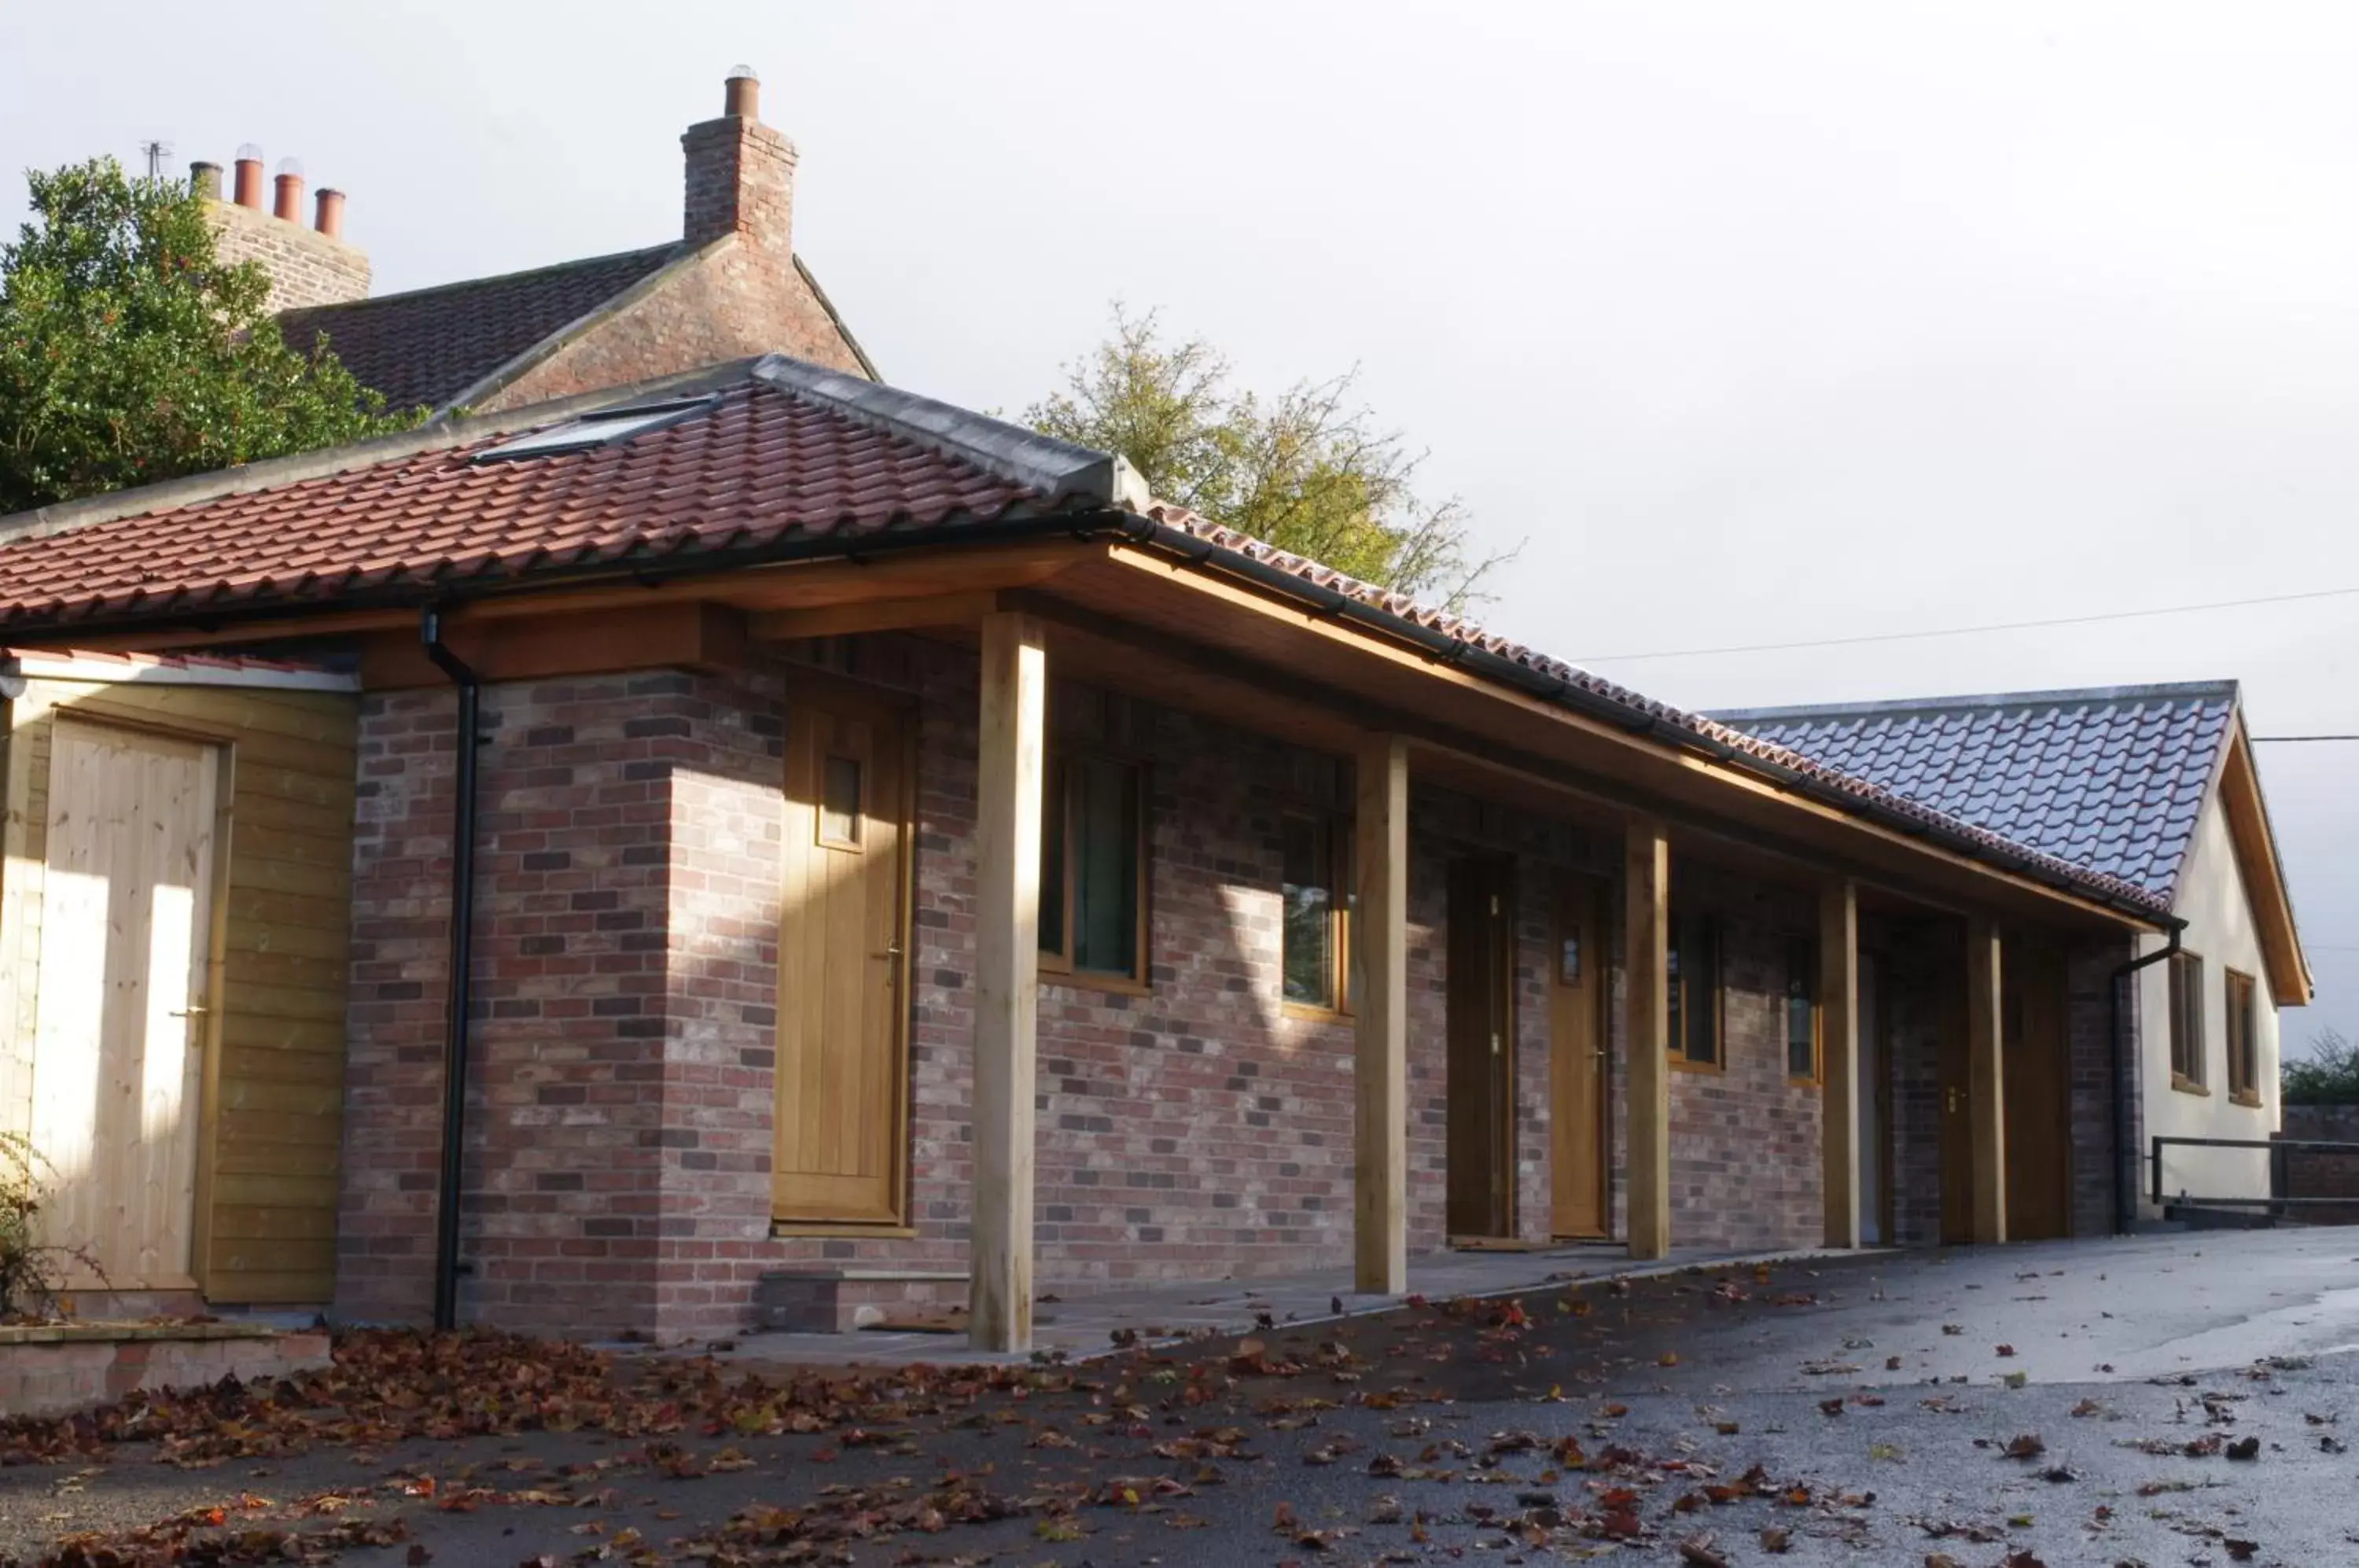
[0,351,2255,1346]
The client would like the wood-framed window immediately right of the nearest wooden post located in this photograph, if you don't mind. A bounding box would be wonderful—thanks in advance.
[1040,753,1146,981]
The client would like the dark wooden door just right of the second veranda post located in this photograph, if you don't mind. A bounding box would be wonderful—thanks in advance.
[1446,858,1514,1235]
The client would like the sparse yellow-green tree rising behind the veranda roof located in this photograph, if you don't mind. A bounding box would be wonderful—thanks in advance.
[1024,304,1514,611]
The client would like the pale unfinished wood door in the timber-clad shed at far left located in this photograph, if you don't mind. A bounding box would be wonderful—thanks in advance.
[31,720,219,1290]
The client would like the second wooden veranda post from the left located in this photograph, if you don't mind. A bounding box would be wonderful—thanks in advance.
[1352,736,1408,1297]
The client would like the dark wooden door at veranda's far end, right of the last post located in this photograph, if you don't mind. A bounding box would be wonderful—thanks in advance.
[2000,940,2071,1240]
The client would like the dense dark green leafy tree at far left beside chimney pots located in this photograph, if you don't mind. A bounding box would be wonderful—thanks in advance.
[0,158,422,514]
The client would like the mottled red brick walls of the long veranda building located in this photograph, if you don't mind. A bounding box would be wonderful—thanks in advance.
[337,637,1944,1337]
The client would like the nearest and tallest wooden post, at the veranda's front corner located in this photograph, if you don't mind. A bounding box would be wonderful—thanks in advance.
[967,611,1047,1351]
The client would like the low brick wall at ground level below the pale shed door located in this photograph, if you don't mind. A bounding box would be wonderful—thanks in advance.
[0,1323,328,1417]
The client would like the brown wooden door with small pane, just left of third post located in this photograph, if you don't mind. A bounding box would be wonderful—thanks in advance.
[1548,877,1611,1235]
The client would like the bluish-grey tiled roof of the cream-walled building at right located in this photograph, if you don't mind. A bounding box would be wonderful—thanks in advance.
[1717,682,2236,898]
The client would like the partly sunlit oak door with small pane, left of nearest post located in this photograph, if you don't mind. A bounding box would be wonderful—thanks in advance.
[771,679,913,1224]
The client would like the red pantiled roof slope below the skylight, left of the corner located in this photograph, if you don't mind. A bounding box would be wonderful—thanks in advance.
[0,360,1043,635]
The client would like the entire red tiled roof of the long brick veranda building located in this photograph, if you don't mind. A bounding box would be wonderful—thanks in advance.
[0,356,2168,917]
